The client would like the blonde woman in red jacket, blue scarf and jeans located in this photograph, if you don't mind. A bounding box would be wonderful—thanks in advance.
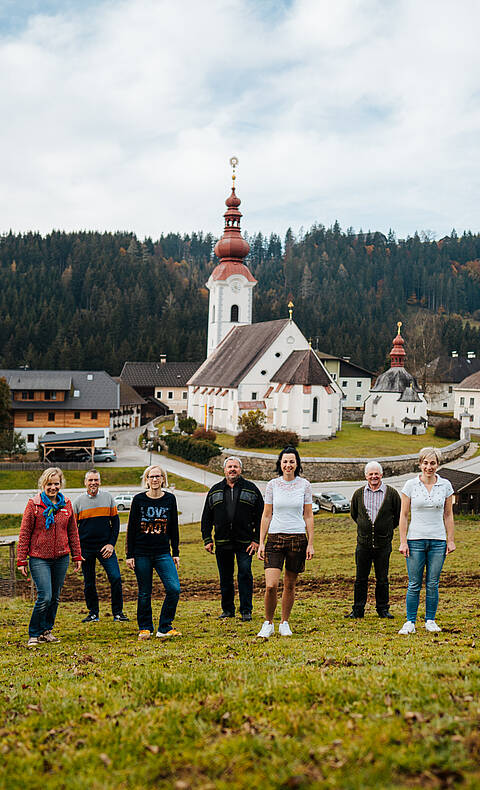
[17,466,82,647]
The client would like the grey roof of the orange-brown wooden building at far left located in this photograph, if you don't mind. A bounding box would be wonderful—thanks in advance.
[0,370,120,411]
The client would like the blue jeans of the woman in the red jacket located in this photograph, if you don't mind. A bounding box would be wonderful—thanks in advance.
[28,554,69,636]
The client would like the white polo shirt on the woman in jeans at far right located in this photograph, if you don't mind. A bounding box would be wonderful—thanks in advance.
[402,475,453,540]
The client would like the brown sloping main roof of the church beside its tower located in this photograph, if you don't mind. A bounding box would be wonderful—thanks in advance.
[188,318,289,387]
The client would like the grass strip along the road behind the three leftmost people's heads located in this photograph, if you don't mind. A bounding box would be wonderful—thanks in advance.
[0,470,208,492]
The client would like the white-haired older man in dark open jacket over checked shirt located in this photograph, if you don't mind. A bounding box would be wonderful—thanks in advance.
[345,461,401,619]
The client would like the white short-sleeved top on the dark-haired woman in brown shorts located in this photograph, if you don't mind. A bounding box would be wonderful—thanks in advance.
[265,477,312,535]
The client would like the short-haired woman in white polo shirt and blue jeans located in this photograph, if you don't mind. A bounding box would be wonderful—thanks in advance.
[398,447,455,634]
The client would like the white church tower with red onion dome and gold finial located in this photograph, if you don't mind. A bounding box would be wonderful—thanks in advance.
[207,156,257,357]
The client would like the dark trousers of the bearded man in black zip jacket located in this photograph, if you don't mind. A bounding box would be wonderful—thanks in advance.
[215,543,253,615]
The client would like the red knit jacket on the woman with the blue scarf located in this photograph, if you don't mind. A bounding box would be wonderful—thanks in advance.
[17,494,82,567]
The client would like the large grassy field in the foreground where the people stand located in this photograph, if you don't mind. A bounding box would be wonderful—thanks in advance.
[0,514,480,790]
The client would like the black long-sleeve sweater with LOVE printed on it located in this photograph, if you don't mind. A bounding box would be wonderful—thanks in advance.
[126,491,179,559]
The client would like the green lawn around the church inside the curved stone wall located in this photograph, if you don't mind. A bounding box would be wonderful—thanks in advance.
[217,422,452,458]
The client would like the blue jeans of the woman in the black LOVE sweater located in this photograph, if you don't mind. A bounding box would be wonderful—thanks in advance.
[135,554,180,634]
